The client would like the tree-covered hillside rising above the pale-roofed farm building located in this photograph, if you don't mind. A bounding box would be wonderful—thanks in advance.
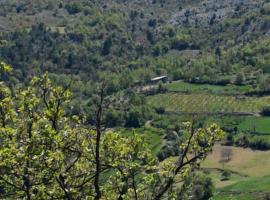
[0,0,270,85]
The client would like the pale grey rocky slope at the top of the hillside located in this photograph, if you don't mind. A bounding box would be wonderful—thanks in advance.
[169,0,262,26]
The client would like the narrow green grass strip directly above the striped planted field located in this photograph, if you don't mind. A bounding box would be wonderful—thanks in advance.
[166,81,252,94]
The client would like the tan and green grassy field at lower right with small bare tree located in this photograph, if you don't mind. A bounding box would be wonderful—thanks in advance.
[202,145,270,200]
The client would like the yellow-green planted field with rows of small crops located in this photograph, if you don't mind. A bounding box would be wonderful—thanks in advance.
[148,93,270,114]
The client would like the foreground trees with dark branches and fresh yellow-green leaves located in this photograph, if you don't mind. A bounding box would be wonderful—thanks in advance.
[0,62,223,200]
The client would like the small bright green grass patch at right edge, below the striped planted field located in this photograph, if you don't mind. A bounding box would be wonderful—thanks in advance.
[238,117,270,134]
